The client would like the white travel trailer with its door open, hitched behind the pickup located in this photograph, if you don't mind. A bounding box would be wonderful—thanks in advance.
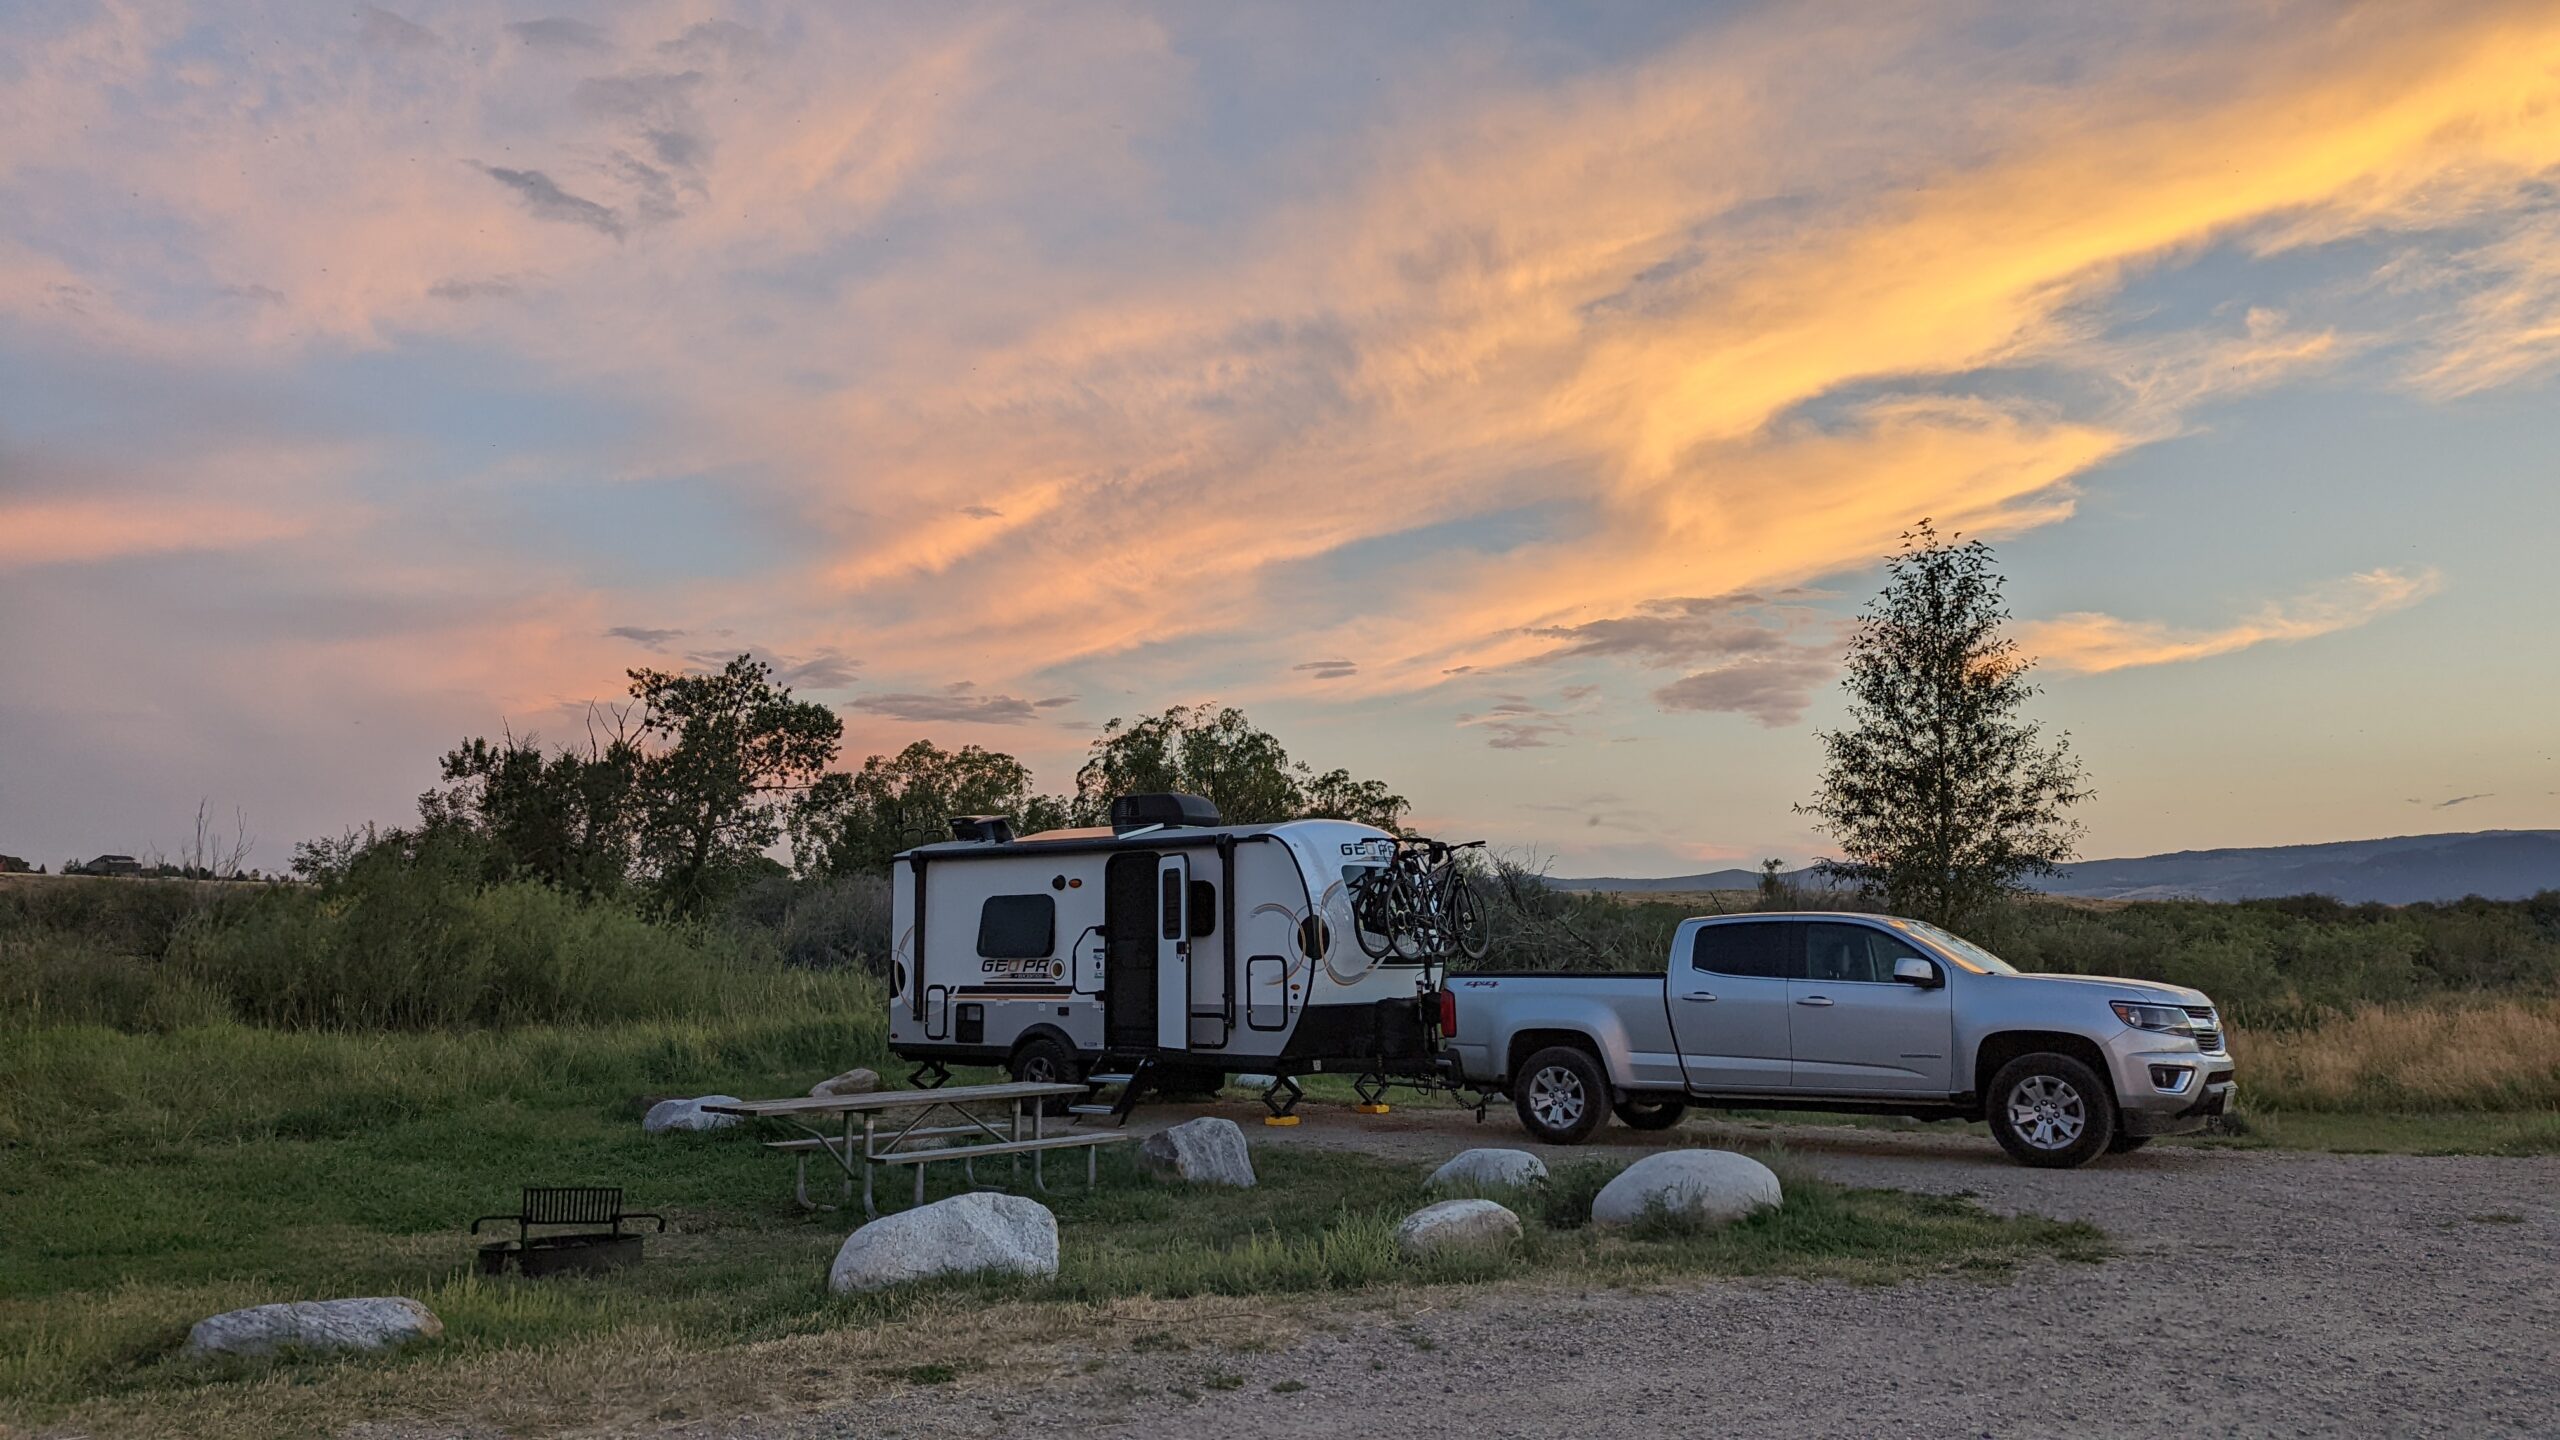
[888,794,1441,1112]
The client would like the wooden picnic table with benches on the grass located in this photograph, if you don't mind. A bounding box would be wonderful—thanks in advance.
[704,1081,1129,1215]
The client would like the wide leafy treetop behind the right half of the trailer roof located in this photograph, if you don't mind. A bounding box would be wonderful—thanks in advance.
[1075,705,1405,830]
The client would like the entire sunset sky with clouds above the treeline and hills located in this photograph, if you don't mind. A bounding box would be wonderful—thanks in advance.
[0,0,2560,874]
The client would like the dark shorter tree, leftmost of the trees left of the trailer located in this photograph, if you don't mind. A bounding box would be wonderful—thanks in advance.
[417,712,643,894]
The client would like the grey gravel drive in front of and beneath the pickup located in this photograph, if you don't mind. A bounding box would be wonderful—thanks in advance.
[634,1104,2560,1440]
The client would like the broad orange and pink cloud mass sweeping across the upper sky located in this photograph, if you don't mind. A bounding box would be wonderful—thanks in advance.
[15,5,2560,737]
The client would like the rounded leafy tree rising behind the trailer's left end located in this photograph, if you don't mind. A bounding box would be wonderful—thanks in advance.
[791,740,1068,876]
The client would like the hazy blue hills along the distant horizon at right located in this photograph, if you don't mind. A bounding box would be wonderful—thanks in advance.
[1551,830,2560,904]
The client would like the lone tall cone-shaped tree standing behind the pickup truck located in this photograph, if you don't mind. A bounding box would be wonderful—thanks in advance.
[1797,520,2089,925]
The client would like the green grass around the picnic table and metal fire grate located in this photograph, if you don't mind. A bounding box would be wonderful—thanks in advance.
[0,1009,2102,1435]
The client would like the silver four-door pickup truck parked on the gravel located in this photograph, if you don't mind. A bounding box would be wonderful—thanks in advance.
[1446,912,2232,1166]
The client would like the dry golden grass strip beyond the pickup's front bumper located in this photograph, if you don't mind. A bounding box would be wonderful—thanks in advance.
[2232,999,2560,1109]
